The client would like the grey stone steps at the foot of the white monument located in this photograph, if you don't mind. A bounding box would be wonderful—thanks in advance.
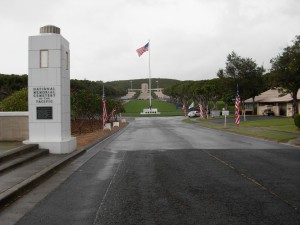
[0,144,66,210]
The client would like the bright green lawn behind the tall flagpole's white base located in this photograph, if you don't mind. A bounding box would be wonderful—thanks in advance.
[122,100,183,116]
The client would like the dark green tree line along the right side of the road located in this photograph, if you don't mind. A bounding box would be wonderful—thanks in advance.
[164,36,300,115]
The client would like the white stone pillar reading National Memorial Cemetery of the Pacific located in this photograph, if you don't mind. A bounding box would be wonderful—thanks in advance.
[24,26,76,154]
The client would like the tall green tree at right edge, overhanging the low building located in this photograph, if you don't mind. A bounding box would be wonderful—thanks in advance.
[271,36,300,117]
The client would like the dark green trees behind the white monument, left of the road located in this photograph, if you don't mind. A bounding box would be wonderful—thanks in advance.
[0,74,124,129]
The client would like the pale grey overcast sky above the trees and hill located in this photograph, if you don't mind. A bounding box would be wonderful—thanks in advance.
[0,0,300,82]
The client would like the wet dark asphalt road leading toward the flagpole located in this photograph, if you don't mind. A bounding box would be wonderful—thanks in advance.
[10,118,300,225]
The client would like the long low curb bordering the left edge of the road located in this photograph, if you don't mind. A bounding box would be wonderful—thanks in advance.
[0,124,127,210]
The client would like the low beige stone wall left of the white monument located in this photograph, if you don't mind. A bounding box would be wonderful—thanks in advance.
[0,112,29,141]
